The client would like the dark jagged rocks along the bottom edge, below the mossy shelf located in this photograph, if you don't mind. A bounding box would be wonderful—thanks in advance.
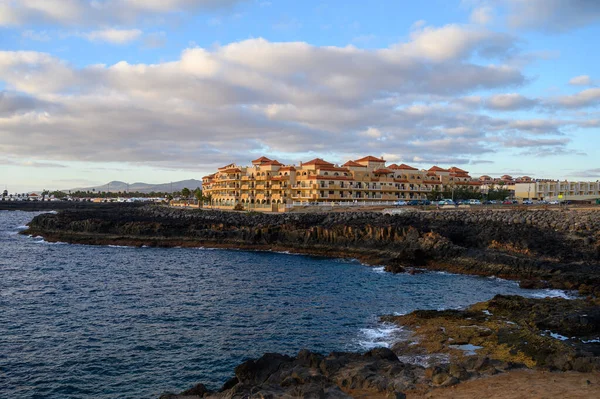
[161,348,493,399]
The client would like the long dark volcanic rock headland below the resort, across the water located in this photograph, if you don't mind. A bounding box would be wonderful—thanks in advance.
[25,206,600,294]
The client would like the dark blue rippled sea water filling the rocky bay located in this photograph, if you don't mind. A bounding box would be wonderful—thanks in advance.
[0,211,572,398]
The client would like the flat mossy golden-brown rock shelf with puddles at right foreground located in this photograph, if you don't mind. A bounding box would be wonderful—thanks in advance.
[383,295,600,372]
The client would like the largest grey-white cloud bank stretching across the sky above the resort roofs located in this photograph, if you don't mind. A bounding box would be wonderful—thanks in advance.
[0,30,584,168]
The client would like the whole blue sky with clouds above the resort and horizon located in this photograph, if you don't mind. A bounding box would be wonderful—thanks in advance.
[0,0,600,192]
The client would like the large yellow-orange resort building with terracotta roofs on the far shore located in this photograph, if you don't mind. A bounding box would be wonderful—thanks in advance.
[202,156,480,211]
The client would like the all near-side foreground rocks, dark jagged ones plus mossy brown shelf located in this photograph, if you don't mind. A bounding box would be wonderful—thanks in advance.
[161,295,600,399]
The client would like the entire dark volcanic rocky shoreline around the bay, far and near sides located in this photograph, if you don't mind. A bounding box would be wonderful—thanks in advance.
[23,206,600,399]
